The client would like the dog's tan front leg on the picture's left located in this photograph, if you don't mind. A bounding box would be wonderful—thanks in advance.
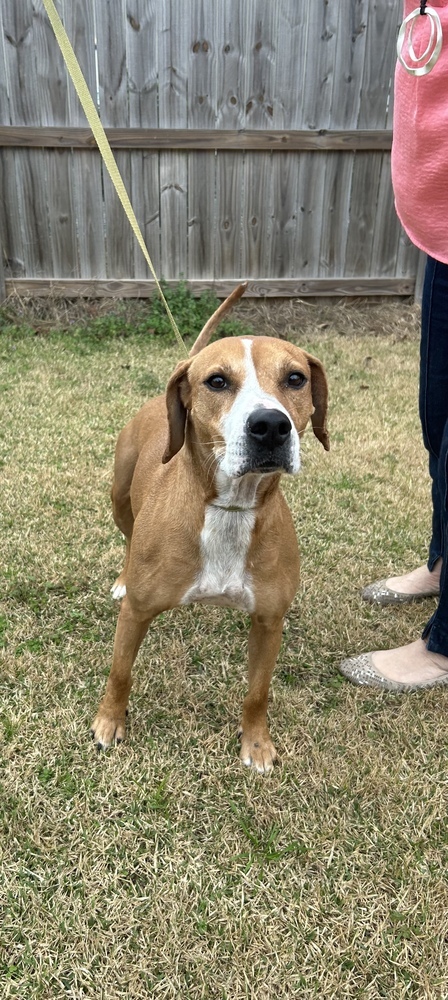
[91,597,153,749]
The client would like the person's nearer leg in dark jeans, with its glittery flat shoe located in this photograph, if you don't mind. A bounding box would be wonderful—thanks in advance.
[341,259,448,687]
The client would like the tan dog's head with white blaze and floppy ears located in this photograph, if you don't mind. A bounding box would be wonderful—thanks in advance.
[163,337,329,478]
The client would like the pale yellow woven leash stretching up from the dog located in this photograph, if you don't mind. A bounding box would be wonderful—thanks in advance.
[43,0,188,354]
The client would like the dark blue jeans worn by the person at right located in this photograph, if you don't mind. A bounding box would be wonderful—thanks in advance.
[419,257,448,656]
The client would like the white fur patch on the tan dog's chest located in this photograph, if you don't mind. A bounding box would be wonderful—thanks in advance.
[181,505,255,612]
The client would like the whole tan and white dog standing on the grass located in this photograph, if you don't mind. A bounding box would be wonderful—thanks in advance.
[92,285,329,772]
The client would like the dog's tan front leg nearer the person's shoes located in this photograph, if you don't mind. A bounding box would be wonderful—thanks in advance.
[240,614,283,773]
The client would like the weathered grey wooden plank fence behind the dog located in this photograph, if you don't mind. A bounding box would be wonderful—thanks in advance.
[0,0,418,296]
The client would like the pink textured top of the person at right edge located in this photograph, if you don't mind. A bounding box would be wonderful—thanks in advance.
[392,0,448,264]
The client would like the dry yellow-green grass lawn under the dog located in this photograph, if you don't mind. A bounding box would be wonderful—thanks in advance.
[0,303,448,1000]
